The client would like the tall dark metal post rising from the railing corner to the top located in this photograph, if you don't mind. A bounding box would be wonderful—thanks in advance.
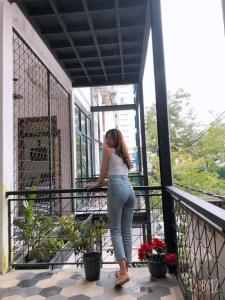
[150,0,176,262]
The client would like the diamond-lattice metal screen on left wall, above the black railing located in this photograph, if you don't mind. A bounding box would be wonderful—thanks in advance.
[13,31,72,190]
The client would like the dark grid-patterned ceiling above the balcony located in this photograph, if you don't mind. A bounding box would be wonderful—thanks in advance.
[13,0,150,87]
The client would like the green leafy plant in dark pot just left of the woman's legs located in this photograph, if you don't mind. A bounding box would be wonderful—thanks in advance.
[58,216,106,281]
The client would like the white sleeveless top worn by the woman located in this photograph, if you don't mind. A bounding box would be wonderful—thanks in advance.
[108,149,128,177]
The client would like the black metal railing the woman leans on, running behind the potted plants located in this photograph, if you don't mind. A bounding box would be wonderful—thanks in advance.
[6,186,164,268]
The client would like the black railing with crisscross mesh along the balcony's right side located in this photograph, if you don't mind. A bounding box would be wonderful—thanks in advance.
[166,187,225,299]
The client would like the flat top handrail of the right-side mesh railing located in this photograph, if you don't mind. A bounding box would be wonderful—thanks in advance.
[165,186,225,232]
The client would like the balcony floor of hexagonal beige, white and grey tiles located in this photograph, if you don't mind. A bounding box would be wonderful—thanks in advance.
[0,268,183,300]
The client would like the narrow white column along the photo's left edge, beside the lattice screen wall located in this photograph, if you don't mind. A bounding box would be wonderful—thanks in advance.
[0,0,13,273]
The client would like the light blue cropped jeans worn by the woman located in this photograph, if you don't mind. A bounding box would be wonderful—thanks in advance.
[107,175,135,263]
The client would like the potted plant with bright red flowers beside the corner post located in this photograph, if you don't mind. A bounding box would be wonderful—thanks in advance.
[138,238,176,278]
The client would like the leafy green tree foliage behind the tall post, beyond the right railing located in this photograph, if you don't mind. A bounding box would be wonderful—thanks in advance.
[146,89,225,195]
